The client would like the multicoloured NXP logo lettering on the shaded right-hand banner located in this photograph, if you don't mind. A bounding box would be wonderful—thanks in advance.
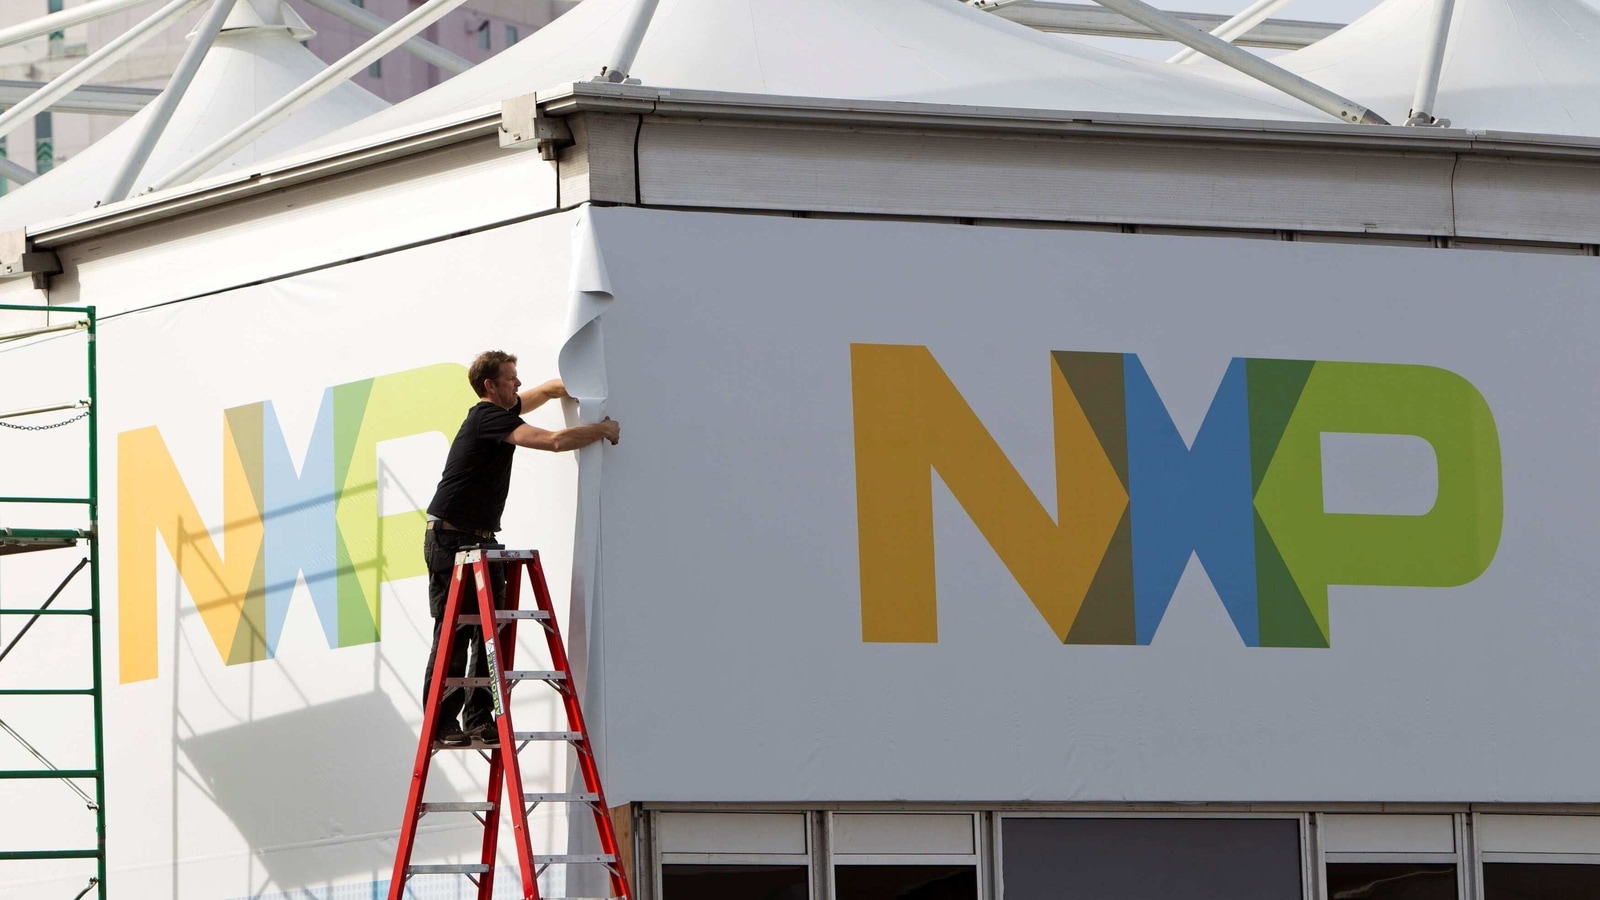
[851,344,1502,647]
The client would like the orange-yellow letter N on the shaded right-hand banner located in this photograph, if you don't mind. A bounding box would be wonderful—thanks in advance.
[850,344,1128,642]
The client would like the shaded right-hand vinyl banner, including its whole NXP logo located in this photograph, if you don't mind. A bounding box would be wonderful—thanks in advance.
[594,210,1600,802]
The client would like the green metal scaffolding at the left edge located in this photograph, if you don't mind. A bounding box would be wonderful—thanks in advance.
[0,304,106,900]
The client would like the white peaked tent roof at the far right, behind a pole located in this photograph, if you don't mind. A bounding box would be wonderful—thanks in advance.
[1197,0,1600,136]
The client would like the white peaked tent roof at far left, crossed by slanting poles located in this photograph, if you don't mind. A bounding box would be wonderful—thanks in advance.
[0,3,387,231]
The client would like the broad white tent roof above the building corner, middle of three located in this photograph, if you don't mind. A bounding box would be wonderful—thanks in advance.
[305,0,1326,144]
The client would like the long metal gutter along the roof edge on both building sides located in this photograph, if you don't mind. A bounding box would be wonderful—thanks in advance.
[29,82,1600,248]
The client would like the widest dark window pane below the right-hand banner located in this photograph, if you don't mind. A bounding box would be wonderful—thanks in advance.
[1000,818,1302,900]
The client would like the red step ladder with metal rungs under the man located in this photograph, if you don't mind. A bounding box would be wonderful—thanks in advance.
[389,549,632,900]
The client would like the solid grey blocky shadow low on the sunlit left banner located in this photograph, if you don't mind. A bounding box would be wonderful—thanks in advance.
[178,692,477,889]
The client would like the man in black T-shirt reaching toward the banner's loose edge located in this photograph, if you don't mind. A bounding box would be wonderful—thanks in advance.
[422,351,621,746]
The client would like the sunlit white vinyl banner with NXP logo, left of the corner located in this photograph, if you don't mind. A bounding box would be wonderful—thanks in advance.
[0,216,578,898]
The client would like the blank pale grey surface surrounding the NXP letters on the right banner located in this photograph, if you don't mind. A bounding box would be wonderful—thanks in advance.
[594,206,1600,804]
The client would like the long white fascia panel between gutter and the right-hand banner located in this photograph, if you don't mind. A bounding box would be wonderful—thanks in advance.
[638,122,1453,234]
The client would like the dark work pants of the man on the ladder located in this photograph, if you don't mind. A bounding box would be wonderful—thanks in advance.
[422,528,506,729]
